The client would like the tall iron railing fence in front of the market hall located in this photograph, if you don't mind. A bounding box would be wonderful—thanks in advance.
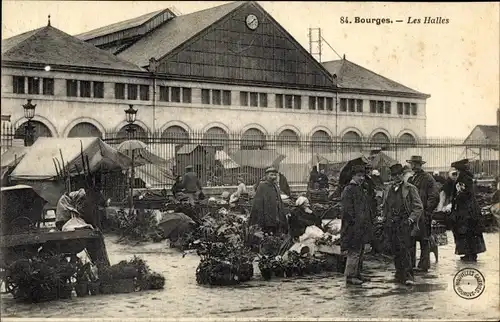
[1,124,499,198]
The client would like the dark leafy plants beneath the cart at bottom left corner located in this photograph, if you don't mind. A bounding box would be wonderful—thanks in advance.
[6,255,77,303]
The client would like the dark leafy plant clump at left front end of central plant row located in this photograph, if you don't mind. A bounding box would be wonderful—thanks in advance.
[196,242,254,286]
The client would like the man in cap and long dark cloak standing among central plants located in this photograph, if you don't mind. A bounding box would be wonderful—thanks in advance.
[249,168,288,233]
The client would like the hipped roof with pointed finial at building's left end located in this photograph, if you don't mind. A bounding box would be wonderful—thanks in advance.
[2,25,143,71]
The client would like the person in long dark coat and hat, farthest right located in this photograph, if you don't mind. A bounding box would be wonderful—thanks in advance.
[451,159,486,262]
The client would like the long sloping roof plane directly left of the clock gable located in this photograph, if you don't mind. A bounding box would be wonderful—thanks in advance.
[114,1,245,67]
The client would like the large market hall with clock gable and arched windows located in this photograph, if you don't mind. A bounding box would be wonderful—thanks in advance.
[2,2,429,148]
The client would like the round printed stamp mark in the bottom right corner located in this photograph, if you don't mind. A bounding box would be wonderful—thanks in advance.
[453,268,486,300]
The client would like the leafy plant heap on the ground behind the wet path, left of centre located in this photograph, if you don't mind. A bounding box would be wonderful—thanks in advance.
[110,209,165,242]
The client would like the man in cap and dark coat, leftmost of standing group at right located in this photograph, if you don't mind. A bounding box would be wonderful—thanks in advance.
[341,165,372,285]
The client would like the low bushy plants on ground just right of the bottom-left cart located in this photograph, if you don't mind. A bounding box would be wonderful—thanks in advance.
[99,256,165,294]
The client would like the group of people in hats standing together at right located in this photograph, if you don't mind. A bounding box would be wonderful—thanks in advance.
[342,156,486,285]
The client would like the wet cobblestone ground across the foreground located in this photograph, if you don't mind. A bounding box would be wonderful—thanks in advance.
[2,233,500,321]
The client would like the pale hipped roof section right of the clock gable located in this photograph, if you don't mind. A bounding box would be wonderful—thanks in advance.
[322,58,429,97]
